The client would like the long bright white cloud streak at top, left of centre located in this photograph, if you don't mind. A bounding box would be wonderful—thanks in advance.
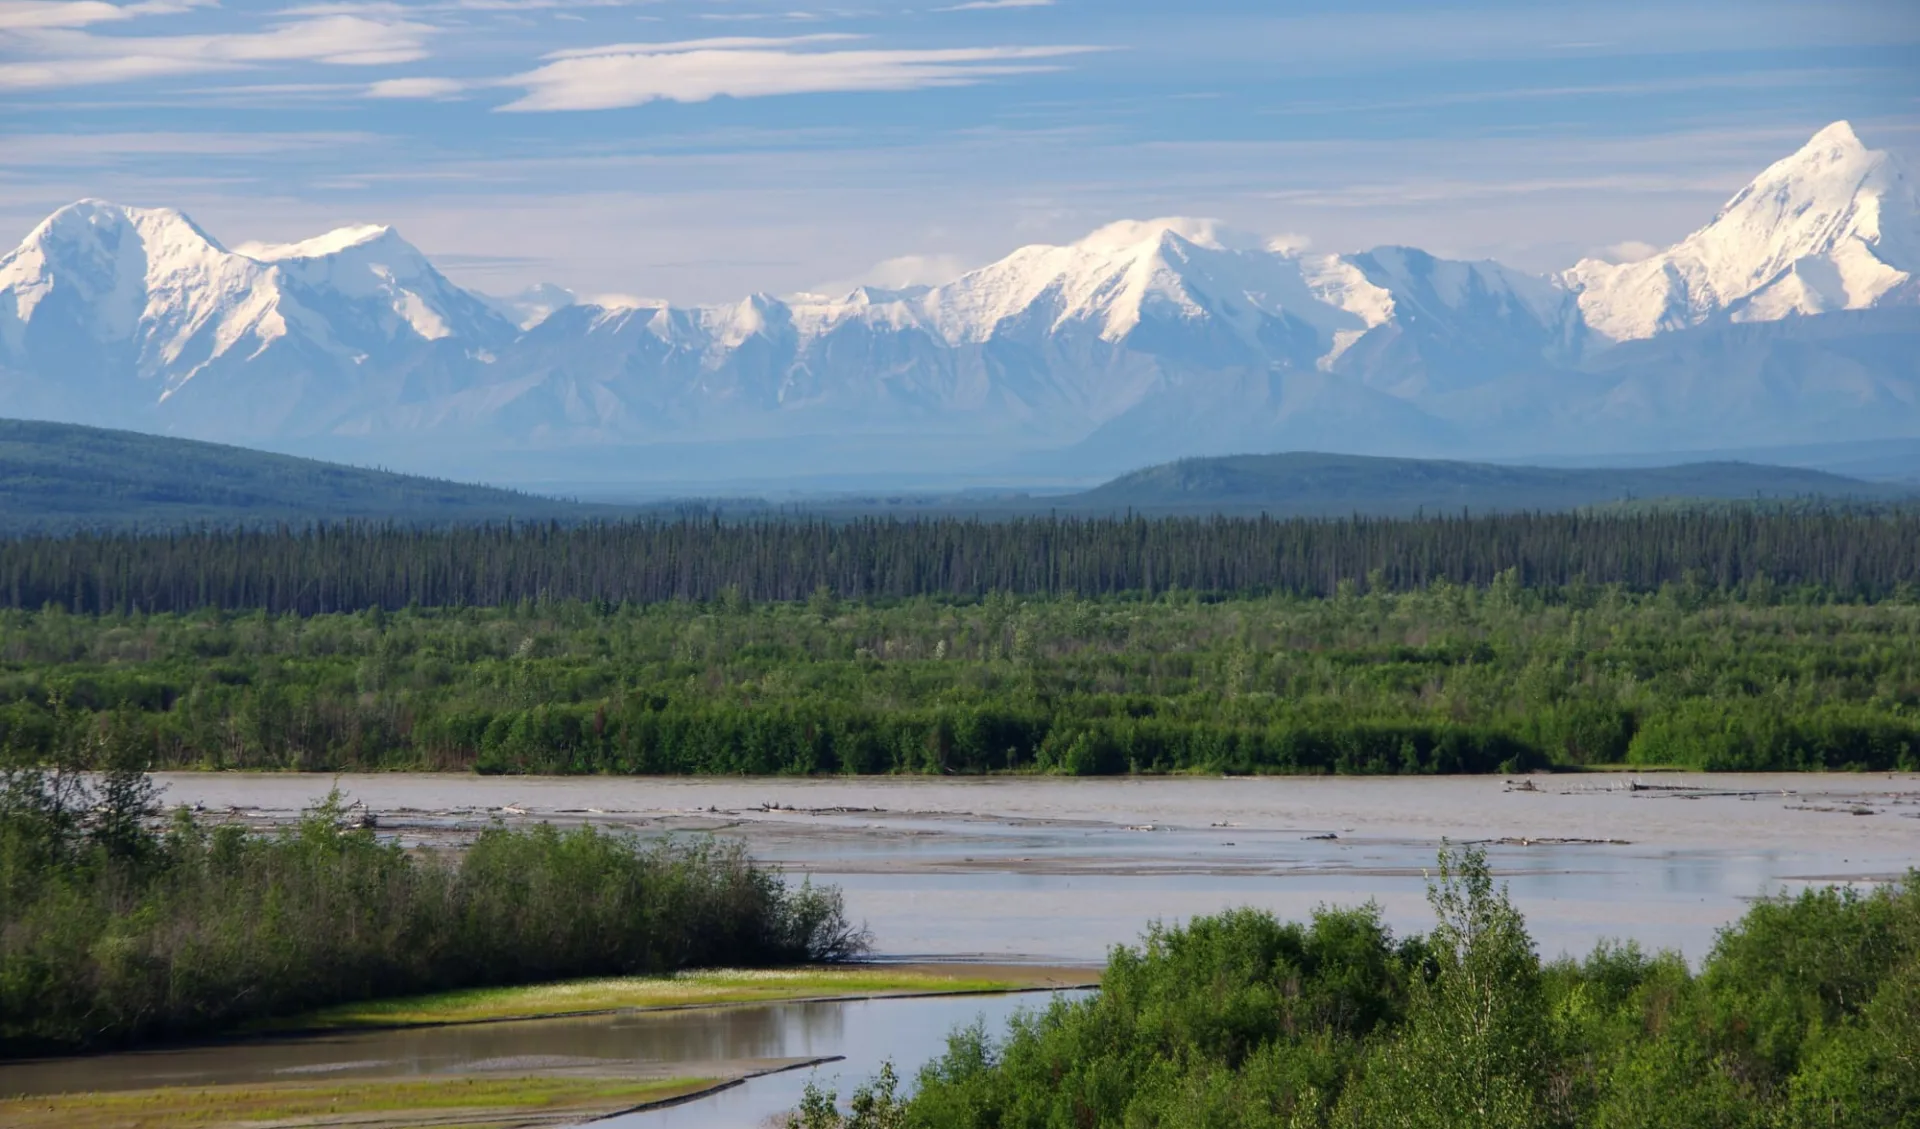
[480,36,1102,111]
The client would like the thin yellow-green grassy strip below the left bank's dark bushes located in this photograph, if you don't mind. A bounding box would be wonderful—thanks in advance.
[261,966,1098,1031]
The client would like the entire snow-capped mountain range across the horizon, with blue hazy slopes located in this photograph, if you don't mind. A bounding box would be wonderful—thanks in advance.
[0,123,1920,476]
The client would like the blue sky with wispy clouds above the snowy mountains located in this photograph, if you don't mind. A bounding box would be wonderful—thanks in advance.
[0,0,1920,301]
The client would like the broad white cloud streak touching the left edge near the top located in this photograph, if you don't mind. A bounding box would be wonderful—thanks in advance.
[0,15,436,90]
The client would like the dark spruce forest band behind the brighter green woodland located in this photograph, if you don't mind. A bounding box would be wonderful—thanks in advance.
[11,507,1920,614]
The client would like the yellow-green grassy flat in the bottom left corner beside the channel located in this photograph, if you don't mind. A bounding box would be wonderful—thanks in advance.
[0,1075,718,1129]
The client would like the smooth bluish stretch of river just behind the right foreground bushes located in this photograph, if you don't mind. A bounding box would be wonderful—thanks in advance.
[812,831,1873,964]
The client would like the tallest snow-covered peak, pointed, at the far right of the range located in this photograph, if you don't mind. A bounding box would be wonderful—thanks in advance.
[1563,121,1920,340]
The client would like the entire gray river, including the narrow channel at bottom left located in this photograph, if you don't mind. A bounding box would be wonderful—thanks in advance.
[11,774,1920,1127]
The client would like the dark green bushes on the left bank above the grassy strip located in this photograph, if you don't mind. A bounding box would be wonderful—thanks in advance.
[0,768,864,1056]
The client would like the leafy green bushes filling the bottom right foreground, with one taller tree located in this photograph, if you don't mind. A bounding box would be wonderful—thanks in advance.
[817,851,1920,1129]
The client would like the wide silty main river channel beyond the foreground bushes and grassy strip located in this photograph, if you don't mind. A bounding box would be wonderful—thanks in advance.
[149,774,1920,962]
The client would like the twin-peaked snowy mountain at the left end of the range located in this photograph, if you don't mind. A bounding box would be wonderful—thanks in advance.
[0,200,516,440]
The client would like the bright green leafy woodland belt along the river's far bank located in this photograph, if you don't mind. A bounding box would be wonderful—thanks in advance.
[0,572,1920,774]
